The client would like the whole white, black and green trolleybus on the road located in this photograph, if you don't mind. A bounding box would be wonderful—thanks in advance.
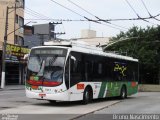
[25,41,138,104]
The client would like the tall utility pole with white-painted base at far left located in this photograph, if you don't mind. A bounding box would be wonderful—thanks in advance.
[1,6,9,89]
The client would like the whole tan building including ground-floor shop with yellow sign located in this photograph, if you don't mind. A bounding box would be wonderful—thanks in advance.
[0,0,25,84]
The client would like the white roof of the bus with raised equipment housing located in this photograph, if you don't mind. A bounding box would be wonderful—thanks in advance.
[32,41,138,62]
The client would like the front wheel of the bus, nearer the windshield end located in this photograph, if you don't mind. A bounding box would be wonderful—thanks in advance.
[82,87,93,105]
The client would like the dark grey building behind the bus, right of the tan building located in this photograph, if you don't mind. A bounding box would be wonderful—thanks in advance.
[24,23,62,48]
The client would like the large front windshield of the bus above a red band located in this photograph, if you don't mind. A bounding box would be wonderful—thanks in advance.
[27,49,66,86]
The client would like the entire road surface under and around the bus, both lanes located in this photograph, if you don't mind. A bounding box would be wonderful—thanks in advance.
[0,90,160,120]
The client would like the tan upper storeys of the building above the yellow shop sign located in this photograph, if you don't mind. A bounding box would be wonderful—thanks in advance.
[0,0,25,47]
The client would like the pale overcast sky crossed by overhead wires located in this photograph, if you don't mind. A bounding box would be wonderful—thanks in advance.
[24,0,160,39]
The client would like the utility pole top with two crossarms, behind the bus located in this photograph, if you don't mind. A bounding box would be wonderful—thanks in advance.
[49,22,65,40]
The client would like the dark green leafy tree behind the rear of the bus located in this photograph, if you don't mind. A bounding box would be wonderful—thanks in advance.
[104,26,160,84]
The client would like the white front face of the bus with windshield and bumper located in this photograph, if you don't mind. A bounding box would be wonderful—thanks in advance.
[26,47,69,101]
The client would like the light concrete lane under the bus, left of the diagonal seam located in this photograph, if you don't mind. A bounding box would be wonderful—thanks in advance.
[0,90,120,120]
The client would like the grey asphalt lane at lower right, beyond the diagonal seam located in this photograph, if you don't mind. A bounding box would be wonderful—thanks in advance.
[77,92,160,120]
